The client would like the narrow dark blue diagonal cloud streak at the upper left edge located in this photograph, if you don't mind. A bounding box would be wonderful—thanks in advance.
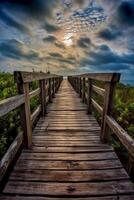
[0,8,30,34]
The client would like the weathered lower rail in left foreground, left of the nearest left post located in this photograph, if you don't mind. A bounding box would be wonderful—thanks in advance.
[0,133,23,181]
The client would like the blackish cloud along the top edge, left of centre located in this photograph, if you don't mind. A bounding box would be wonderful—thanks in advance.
[0,0,55,19]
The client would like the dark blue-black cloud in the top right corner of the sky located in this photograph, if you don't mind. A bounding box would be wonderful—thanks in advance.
[118,0,134,25]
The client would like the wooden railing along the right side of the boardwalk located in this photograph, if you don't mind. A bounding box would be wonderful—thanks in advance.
[68,73,134,173]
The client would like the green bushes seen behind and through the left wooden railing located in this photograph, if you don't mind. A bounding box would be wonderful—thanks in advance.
[0,73,39,158]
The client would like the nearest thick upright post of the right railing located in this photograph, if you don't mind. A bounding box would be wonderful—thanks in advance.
[101,81,116,142]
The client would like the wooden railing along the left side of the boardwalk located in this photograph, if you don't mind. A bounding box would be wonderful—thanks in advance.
[0,71,63,180]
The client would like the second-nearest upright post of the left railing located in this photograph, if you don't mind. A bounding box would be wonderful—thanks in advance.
[39,79,46,117]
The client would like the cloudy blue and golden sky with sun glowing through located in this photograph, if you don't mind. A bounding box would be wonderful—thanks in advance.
[0,0,134,83]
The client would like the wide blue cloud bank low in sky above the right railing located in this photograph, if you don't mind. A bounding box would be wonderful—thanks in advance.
[80,45,134,70]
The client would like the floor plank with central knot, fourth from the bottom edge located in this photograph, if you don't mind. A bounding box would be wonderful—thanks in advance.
[15,159,122,170]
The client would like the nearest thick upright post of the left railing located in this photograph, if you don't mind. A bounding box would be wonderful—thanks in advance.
[17,83,32,148]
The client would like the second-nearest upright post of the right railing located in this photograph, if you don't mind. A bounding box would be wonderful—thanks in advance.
[87,78,92,114]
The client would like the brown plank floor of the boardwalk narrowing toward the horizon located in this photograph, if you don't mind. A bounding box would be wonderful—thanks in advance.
[1,80,134,200]
